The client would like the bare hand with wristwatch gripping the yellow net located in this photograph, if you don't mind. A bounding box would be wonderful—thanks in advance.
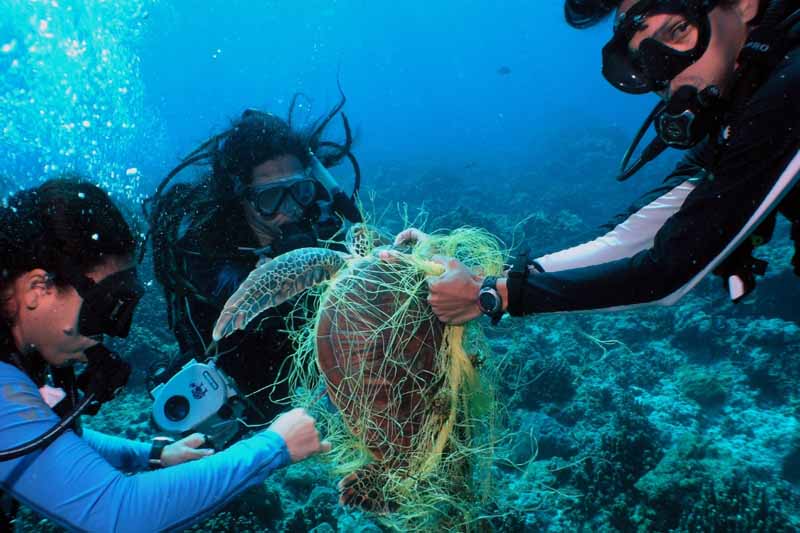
[428,255,481,325]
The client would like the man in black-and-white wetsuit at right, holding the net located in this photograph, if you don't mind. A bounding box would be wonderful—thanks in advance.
[397,0,800,323]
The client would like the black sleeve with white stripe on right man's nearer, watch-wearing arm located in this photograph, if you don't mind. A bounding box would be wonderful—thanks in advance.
[509,48,800,315]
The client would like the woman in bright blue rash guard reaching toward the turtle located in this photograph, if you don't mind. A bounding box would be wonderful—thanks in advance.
[0,178,329,531]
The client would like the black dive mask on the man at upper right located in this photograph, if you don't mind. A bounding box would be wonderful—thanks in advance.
[603,0,718,94]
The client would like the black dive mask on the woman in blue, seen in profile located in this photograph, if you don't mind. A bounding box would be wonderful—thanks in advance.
[68,268,144,337]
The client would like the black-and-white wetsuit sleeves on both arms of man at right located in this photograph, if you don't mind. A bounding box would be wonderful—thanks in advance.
[509,28,800,315]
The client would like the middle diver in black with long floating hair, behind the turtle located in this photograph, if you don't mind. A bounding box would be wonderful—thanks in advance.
[148,96,359,423]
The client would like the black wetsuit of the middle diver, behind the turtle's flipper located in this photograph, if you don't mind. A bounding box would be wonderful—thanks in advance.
[172,206,292,422]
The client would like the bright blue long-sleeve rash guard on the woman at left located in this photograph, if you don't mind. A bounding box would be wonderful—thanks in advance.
[0,363,290,531]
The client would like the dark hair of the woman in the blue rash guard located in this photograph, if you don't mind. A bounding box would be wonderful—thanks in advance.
[0,174,140,328]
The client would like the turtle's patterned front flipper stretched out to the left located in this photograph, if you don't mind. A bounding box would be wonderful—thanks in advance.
[213,248,348,341]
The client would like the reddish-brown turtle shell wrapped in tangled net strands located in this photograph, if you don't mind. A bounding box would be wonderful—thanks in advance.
[316,257,444,463]
